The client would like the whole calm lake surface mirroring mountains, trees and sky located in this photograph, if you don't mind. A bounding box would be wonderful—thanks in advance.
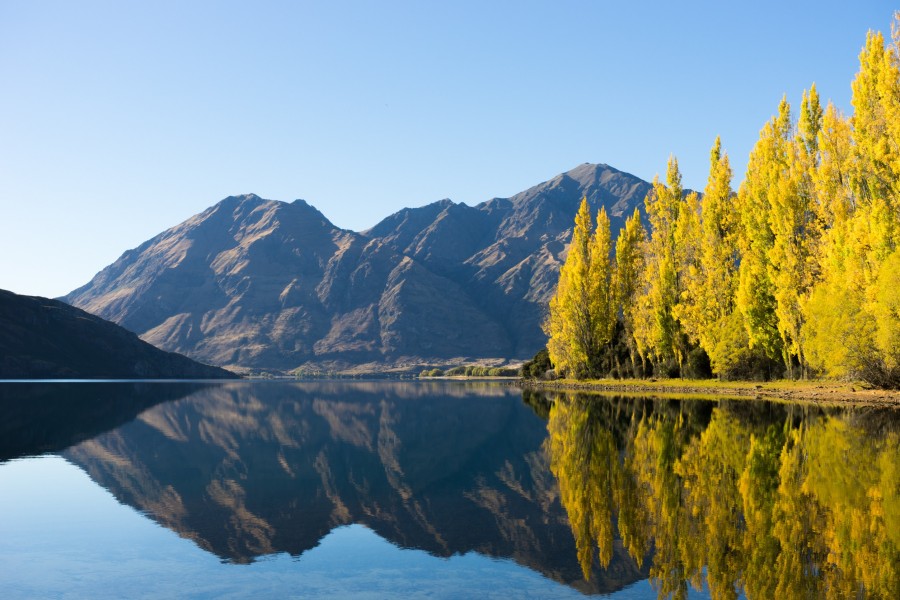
[0,381,900,598]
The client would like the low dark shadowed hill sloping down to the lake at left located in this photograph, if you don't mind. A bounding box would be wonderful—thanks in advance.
[0,290,237,379]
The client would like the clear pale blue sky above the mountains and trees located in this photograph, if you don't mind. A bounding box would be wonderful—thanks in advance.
[0,0,896,296]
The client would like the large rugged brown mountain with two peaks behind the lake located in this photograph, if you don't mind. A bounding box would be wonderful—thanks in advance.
[63,164,650,372]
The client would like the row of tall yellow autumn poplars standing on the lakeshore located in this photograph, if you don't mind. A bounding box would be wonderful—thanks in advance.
[545,13,900,387]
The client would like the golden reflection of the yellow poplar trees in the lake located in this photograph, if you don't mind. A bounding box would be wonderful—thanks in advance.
[526,394,900,599]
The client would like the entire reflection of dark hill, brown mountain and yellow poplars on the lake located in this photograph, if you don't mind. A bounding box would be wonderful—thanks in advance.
[0,381,900,599]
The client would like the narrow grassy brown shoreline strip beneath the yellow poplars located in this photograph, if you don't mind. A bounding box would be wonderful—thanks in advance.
[517,379,900,408]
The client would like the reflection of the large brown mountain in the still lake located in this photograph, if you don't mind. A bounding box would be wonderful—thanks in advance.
[56,382,646,592]
